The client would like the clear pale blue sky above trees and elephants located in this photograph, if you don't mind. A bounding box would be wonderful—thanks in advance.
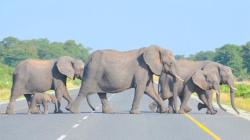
[0,0,250,55]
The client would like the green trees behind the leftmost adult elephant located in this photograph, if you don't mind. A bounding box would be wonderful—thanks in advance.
[0,37,89,67]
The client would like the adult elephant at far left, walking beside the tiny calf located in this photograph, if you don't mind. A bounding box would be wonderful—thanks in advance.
[6,56,84,114]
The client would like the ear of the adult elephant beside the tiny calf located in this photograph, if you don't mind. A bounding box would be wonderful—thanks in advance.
[56,56,75,79]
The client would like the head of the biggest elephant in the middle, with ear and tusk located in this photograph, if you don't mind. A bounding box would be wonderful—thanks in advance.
[143,45,181,79]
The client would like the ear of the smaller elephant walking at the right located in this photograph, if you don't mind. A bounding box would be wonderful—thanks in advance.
[192,70,209,90]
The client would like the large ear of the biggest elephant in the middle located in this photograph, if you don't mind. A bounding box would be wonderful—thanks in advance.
[143,45,162,75]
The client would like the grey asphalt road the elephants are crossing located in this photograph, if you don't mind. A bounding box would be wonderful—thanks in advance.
[0,90,250,140]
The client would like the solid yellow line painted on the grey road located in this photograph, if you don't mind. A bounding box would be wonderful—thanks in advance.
[184,114,221,140]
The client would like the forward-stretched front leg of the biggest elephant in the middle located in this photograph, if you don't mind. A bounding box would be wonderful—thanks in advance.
[145,82,168,113]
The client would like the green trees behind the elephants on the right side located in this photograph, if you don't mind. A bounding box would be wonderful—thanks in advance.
[176,42,250,80]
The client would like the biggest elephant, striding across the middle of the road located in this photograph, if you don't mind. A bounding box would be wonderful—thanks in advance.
[67,45,182,114]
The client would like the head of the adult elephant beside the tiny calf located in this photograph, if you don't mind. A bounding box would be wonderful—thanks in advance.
[56,56,84,79]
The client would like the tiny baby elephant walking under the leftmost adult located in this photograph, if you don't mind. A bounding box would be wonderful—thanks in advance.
[28,93,57,114]
